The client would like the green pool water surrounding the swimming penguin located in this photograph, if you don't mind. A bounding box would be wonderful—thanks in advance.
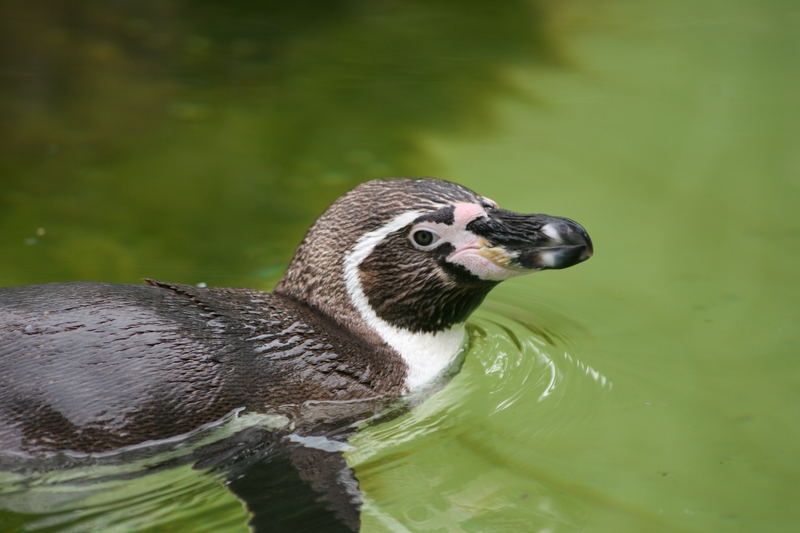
[0,0,800,532]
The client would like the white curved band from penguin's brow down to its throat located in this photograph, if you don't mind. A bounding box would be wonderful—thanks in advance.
[344,211,464,391]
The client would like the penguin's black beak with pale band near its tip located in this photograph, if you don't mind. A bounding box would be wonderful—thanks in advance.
[467,209,594,274]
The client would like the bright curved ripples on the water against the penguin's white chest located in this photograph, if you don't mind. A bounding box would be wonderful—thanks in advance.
[349,306,613,465]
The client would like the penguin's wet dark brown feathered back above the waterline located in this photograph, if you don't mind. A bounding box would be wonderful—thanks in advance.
[0,282,403,452]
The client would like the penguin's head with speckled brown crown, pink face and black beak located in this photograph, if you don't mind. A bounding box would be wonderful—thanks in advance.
[276,178,592,332]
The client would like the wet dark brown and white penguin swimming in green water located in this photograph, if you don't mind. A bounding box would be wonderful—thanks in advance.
[0,178,592,528]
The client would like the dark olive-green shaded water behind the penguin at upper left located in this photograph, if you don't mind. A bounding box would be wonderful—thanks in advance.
[0,0,554,286]
